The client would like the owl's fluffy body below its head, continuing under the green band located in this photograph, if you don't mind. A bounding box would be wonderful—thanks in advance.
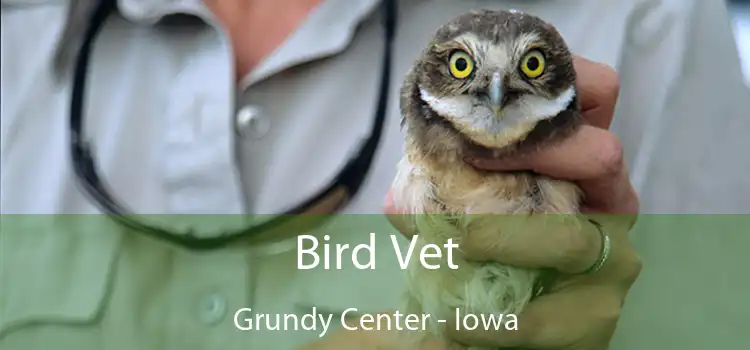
[393,146,579,350]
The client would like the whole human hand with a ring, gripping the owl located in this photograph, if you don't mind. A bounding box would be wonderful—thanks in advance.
[386,57,641,350]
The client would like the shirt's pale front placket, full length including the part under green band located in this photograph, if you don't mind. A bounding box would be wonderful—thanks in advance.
[124,3,262,349]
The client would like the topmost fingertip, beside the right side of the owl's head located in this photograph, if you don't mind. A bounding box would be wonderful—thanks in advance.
[573,56,620,129]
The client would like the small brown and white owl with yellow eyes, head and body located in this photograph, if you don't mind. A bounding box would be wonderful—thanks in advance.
[392,10,582,349]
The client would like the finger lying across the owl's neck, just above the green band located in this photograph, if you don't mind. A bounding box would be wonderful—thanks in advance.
[468,125,638,213]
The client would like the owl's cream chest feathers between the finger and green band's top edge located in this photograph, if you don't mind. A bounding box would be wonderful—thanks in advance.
[394,145,580,214]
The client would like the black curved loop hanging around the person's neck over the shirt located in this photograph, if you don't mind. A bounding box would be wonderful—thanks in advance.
[70,0,396,250]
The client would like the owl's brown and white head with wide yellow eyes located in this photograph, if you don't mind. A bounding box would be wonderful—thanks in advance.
[402,10,578,149]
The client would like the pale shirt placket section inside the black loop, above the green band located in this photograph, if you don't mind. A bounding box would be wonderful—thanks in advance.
[163,30,243,219]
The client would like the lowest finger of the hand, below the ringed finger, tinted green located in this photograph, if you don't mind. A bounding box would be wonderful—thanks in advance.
[447,286,622,350]
